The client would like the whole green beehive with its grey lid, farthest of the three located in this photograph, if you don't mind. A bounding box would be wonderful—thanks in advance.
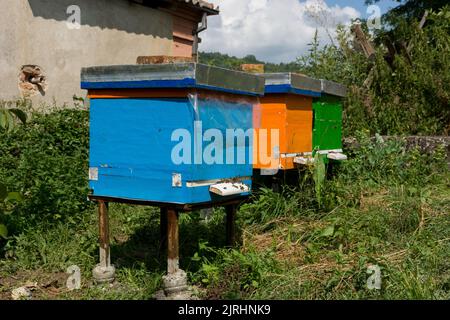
[313,80,347,160]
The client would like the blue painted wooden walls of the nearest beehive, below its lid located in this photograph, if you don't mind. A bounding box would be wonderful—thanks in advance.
[90,98,252,203]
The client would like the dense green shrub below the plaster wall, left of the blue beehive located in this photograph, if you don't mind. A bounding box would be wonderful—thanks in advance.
[0,110,89,232]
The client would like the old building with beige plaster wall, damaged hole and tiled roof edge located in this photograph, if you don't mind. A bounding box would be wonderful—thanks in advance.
[0,0,218,105]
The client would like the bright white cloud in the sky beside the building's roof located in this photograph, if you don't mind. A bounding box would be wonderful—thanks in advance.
[200,0,360,62]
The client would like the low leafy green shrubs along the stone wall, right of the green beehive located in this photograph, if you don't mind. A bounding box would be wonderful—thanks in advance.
[324,132,448,208]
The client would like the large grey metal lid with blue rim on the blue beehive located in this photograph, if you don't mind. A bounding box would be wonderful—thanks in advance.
[81,63,264,95]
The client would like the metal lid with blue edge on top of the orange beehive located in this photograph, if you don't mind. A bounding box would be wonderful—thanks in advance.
[264,72,322,97]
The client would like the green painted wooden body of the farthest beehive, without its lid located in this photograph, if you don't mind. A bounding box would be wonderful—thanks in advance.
[313,96,342,150]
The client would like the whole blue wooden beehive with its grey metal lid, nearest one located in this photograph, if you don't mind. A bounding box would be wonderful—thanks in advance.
[82,63,264,204]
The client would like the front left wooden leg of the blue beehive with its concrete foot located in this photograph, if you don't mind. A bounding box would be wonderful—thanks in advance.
[92,200,115,283]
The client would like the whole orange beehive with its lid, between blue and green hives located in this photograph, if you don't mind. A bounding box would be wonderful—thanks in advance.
[254,73,321,170]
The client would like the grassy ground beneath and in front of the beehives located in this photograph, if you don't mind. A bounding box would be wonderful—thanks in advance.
[0,177,450,299]
